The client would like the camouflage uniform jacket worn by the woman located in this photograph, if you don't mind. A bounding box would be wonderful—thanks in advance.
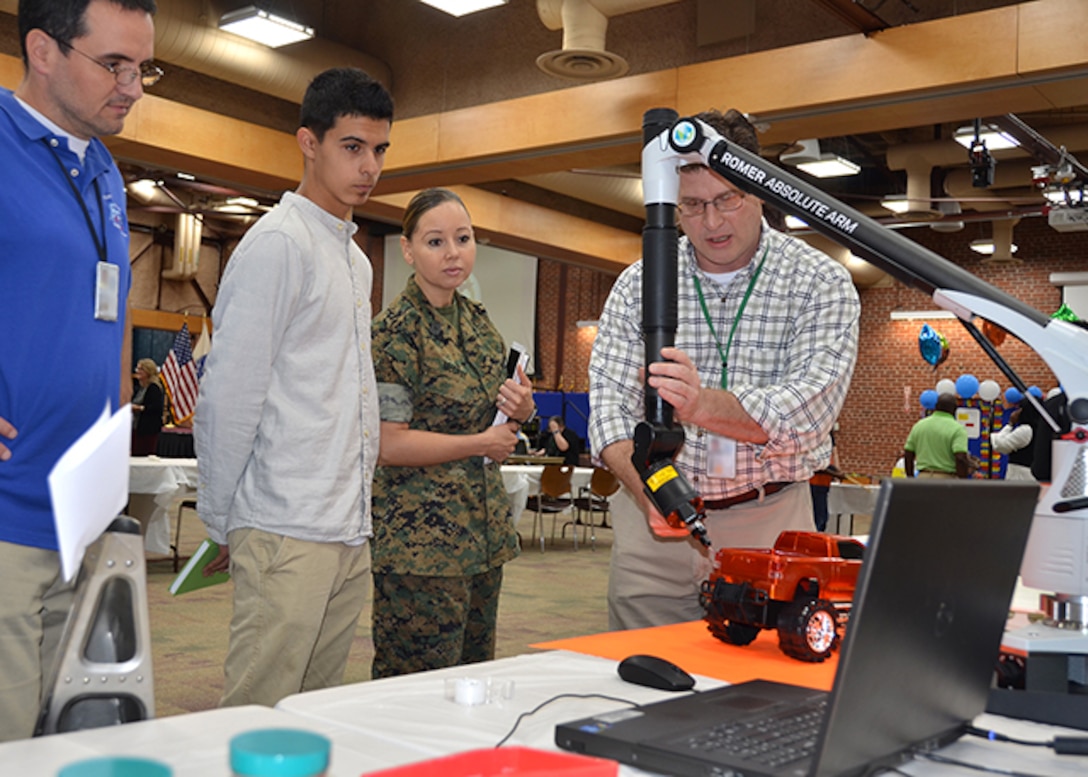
[372,276,518,577]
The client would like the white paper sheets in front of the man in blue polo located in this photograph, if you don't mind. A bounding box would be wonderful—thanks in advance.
[48,403,132,580]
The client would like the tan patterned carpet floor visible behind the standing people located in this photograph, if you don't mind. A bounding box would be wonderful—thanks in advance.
[147,504,611,717]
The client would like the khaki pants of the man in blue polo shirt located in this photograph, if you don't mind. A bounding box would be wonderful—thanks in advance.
[0,542,73,742]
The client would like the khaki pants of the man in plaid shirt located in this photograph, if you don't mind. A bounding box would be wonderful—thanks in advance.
[608,482,814,630]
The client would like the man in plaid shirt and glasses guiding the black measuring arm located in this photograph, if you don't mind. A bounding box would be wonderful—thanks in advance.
[590,110,861,629]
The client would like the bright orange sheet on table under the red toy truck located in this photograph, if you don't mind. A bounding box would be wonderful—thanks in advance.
[530,620,839,690]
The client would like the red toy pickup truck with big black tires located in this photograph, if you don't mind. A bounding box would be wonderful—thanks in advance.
[700,531,865,662]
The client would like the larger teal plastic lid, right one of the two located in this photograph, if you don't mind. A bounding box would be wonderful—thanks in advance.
[231,728,332,777]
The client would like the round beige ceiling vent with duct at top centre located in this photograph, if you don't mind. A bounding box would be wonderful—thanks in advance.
[536,0,677,82]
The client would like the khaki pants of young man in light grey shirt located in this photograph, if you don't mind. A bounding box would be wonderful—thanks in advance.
[220,529,370,706]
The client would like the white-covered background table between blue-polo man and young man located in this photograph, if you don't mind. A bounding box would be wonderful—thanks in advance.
[128,456,197,554]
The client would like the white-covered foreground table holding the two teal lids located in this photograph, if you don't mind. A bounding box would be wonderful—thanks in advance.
[0,705,426,777]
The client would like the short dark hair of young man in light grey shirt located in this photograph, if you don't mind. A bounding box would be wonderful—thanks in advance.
[298,67,393,140]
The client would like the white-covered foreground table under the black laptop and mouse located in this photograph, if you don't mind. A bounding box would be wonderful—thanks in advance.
[274,651,1088,777]
